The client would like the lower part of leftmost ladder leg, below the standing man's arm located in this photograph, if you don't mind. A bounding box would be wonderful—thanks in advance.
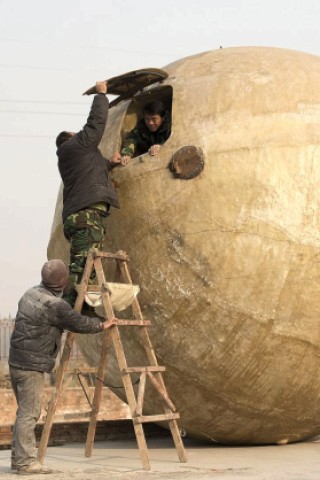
[38,332,75,463]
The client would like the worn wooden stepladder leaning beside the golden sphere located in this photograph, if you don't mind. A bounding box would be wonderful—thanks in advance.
[38,249,187,470]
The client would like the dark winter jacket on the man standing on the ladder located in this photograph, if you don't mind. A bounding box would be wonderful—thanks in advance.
[57,94,119,221]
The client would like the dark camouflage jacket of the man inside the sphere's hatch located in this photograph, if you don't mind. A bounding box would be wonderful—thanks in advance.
[121,112,171,157]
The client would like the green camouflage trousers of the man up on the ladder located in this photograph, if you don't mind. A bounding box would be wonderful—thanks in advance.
[63,208,108,307]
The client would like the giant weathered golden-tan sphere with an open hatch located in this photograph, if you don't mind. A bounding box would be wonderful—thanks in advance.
[49,47,320,444]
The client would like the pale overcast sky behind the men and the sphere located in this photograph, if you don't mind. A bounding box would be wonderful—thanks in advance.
[0,0,320,318]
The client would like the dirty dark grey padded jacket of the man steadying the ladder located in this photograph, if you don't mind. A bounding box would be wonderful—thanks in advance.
[9,284,103,373]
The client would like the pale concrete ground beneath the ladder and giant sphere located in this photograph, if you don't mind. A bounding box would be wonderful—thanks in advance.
[0,437,320,480]
